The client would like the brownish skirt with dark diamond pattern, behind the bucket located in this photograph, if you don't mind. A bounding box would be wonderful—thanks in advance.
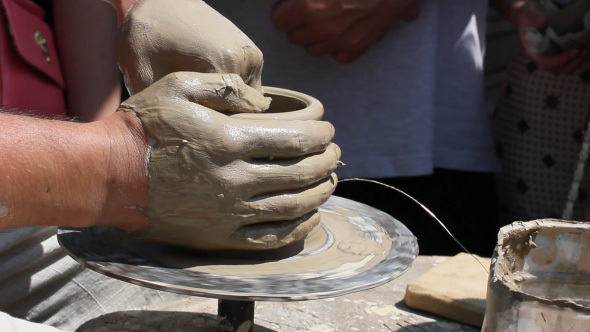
[493,53,590,224]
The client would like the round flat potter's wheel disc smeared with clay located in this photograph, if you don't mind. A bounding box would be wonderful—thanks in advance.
[58,196,418,301]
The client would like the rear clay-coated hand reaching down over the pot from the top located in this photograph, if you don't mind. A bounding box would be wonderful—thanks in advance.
[117,0,263,94]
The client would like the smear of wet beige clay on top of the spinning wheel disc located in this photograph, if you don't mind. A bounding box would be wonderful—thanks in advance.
[154,211,392,278]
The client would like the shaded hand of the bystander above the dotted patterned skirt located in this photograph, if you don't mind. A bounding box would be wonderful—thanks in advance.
[505,0,590,74]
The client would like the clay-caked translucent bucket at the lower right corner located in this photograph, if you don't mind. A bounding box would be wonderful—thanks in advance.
[482,219,590,332]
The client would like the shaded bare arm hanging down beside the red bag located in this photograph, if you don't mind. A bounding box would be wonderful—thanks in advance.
[53,0,121,122]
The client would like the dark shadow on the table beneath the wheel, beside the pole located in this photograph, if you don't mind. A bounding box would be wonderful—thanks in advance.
[76,310,276,332]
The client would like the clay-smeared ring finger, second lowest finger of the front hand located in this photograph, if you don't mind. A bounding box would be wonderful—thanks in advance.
[239,173,338,224]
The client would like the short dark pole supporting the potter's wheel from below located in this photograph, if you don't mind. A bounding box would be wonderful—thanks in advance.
[217,299,254,332]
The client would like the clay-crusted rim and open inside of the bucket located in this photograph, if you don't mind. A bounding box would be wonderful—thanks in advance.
[492,220,590,305]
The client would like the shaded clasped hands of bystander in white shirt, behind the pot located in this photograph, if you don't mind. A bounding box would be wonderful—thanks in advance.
[271,0,420,63]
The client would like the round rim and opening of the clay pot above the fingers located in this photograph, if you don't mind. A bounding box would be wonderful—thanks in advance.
[229,87,324,120]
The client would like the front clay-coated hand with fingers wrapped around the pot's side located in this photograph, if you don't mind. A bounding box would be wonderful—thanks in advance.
[121,72,340,249]
